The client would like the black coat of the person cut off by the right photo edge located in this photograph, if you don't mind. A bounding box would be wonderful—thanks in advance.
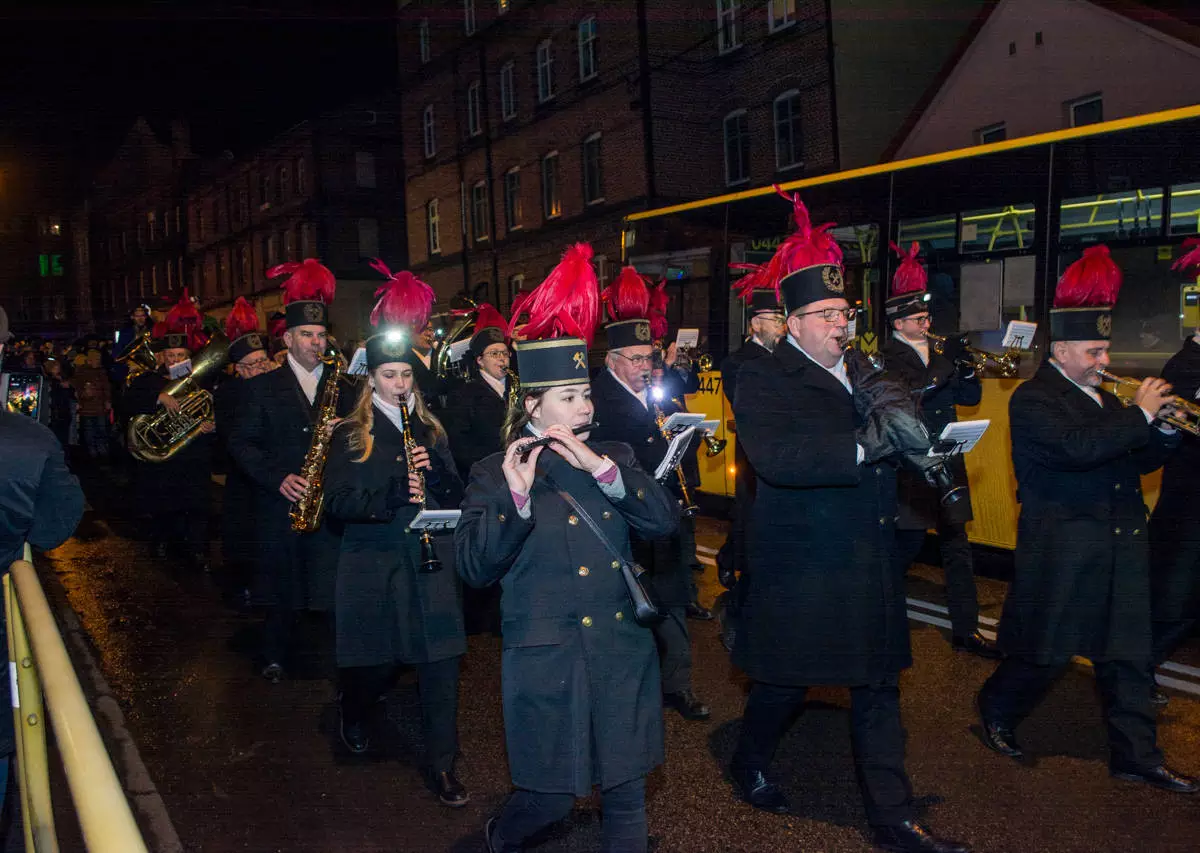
[1150,337,1200,621]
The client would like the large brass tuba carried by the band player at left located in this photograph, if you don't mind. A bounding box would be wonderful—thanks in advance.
[126,332,229,462]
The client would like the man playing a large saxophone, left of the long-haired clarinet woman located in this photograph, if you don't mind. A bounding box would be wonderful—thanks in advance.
[229,258,353,683]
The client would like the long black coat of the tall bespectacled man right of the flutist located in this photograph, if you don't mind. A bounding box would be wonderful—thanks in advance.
[733,341,912,686]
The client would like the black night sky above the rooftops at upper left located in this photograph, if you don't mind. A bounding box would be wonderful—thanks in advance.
[0,0,396,197]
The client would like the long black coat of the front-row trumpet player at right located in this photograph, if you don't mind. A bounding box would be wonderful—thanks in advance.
[998,362,1178,665]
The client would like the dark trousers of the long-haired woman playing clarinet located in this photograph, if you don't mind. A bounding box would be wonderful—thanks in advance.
[337,657,460,774]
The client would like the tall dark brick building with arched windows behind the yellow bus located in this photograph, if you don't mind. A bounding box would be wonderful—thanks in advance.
[400,0,978,340]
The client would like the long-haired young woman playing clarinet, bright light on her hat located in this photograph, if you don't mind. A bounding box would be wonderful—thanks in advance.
[325,260,470,807]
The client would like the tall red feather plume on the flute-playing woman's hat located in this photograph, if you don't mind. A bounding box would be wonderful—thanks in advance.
[512,242,600,344]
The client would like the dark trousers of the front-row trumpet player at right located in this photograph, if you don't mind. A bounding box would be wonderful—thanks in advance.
[979,657,1163,770]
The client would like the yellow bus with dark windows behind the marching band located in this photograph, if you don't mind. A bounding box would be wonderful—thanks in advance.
[622,106,1200,548]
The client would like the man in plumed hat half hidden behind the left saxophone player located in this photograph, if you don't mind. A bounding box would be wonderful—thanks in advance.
[212,296,277,601]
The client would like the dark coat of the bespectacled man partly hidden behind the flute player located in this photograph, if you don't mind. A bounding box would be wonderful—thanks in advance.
[592,368,691,607]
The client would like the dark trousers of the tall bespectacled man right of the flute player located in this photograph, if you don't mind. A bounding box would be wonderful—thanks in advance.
[733,674,912,827]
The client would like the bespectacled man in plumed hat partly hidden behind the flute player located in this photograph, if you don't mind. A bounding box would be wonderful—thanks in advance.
[592,266,710,720]
